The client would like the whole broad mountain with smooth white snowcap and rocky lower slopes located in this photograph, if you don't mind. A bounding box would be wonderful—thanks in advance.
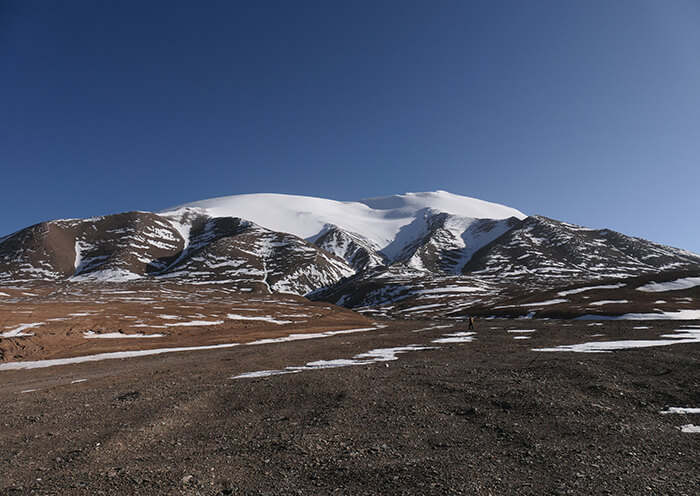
[0,191,700,318]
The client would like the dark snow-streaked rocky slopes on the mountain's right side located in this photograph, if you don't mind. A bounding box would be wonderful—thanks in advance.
[311,216,700,318]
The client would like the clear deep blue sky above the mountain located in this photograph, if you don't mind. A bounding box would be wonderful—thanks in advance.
[0,0,700,253]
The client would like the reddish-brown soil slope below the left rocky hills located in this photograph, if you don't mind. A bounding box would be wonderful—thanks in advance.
[0,283,373,363]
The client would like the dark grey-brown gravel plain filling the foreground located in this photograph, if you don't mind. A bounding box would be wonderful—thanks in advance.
[0,320,700,496]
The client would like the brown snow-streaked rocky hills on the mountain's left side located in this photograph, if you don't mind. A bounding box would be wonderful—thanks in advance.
[0,212,355,294]
